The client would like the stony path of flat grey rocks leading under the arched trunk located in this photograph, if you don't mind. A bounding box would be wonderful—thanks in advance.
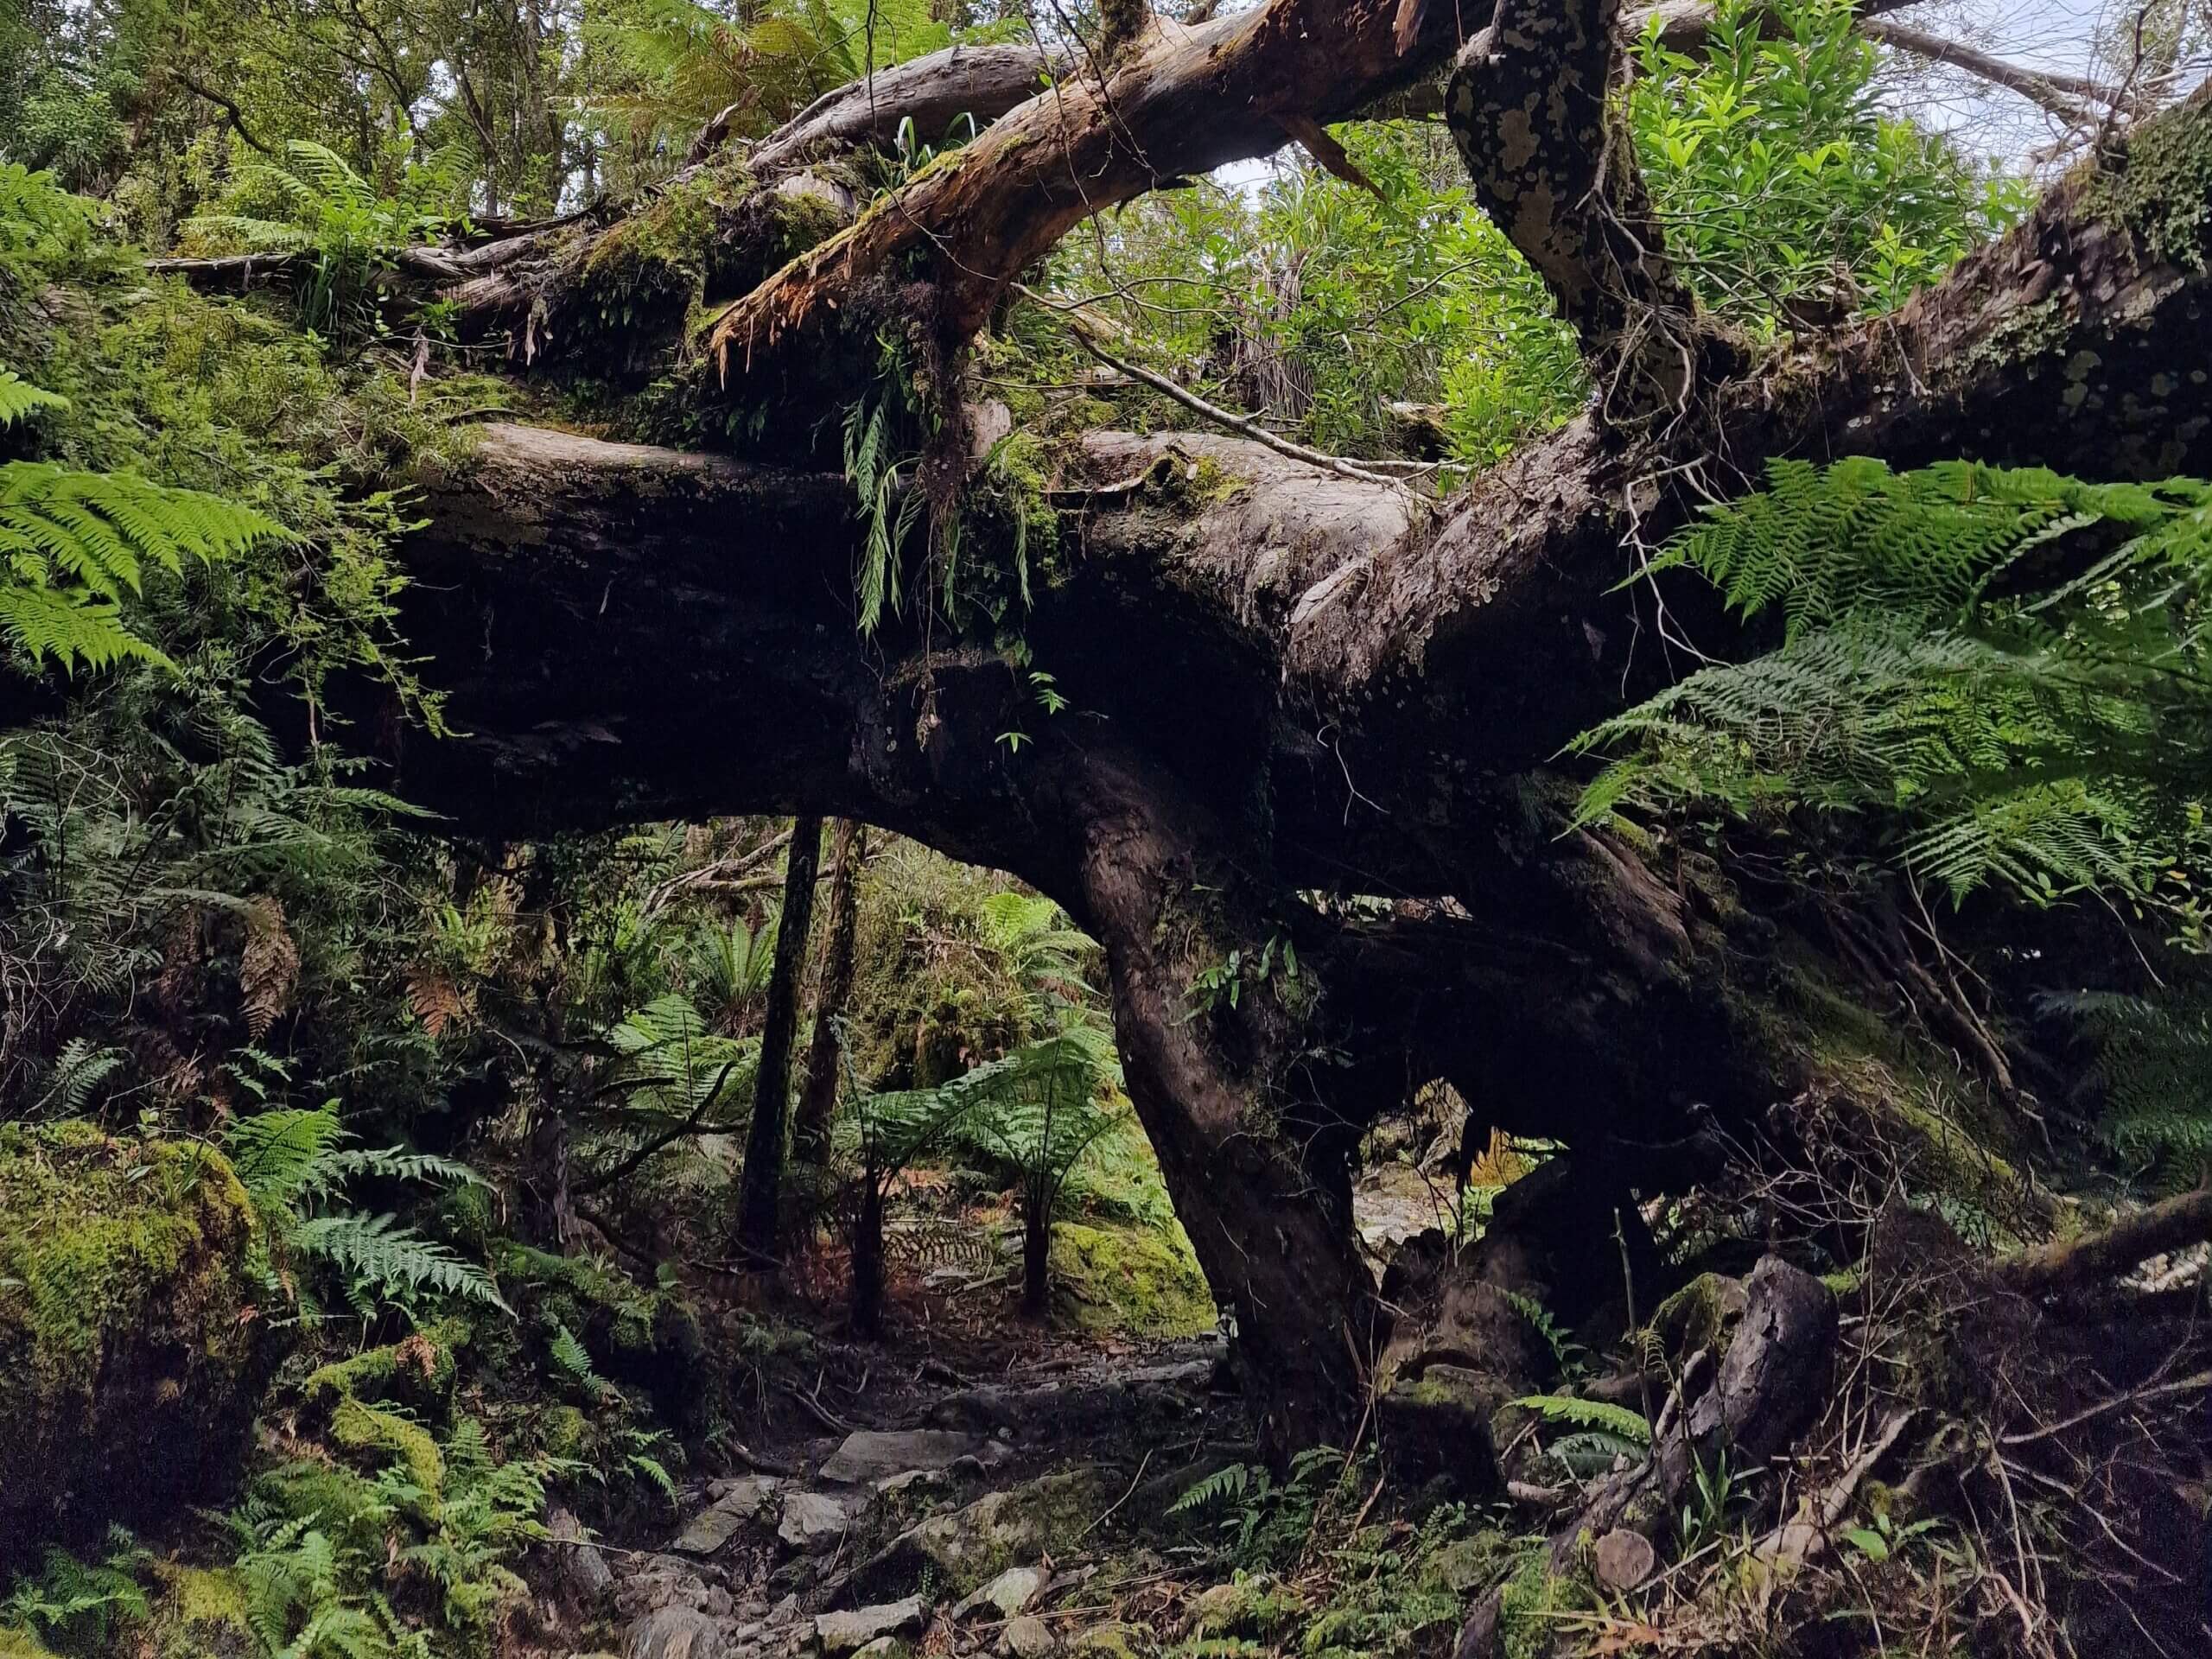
[542,1336,1245,1659]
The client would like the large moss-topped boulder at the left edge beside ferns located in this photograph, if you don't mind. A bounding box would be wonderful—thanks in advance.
[0,1122,279,1551]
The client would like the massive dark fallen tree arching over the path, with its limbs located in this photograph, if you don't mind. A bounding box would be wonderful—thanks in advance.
[349,13,2212,1446]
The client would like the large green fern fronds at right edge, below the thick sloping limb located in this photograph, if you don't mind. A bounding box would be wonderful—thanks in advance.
[1575,460,2212,912]
